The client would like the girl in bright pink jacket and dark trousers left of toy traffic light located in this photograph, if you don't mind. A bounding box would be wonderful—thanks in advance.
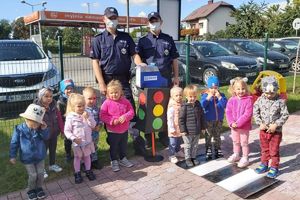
[100,80,134,172]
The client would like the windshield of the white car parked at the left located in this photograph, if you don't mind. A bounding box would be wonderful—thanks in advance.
[0,42,45,61]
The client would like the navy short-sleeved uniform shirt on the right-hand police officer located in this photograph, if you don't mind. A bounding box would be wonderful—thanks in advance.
[137,32,179,78]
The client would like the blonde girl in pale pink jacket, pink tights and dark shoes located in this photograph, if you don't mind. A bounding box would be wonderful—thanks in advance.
[64,93,96,184]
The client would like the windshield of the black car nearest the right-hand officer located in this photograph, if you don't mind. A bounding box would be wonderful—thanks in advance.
[194,43,233,57]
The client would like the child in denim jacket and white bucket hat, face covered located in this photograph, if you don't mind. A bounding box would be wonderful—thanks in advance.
[9,104,49,199]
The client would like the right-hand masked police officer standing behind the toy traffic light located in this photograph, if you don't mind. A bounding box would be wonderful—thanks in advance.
[137,12,179,146]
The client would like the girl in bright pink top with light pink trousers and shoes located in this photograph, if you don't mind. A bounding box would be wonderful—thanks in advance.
[226,77,253,168]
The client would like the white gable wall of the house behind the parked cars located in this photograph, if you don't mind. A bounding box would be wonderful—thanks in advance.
[207,7,236,34]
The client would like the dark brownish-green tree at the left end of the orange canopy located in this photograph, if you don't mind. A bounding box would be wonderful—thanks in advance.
[11,17,29,39]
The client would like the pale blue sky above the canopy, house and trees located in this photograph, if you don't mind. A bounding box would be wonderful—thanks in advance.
[0,0,285,22]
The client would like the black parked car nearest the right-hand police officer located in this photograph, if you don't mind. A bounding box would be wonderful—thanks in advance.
[175,41,261,84]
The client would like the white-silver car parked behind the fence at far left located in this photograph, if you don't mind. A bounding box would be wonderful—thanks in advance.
[0,40,61,115]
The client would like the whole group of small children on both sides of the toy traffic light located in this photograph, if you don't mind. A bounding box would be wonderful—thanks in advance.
[10,76,288,199]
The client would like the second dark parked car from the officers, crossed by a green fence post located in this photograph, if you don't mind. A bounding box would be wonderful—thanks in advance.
[215,39,290,75]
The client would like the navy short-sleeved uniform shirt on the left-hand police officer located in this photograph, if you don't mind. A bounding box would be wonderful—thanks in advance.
[90,30,137,76]
